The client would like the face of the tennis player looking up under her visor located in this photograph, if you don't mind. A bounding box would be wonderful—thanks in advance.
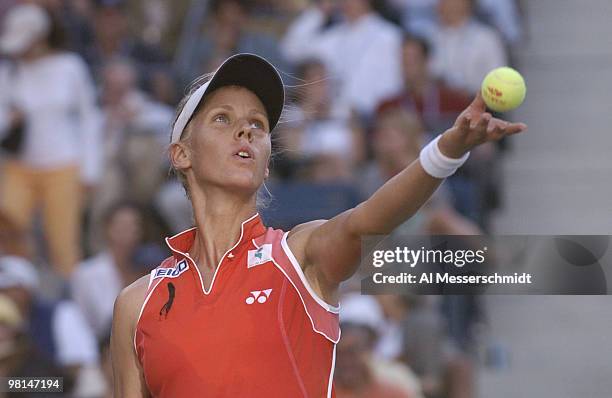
[178,86,271,194]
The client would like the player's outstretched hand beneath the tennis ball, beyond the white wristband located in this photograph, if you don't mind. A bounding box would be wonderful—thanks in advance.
[438,92,527,159]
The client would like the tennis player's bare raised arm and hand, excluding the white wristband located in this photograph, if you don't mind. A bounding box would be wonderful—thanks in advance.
[288,95,527,302]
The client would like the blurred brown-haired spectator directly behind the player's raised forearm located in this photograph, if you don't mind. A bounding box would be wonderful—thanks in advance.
[359,109,480,236]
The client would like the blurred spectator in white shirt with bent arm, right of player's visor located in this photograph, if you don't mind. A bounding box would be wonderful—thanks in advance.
[282,0,401,116]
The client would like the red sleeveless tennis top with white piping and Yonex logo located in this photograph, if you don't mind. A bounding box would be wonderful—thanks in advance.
[134,214,340,398]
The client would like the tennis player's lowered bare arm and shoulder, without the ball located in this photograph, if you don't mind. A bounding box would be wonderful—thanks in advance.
[111,276,149,398]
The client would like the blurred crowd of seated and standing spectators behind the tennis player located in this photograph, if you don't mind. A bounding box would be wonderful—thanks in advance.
[0,0,525,398]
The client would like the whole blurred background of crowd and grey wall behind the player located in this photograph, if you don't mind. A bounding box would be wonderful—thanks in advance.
[0,0,612,398]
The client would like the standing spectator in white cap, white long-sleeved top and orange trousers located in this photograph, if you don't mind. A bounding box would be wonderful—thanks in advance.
[0,4,102,278]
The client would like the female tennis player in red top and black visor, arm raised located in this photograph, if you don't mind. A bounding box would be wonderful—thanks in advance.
[111,54,526,398]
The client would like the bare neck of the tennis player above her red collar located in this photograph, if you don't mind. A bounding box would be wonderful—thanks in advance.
[189,187,257,270]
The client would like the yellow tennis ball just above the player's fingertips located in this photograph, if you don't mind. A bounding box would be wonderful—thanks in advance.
[482,67,527,112]
